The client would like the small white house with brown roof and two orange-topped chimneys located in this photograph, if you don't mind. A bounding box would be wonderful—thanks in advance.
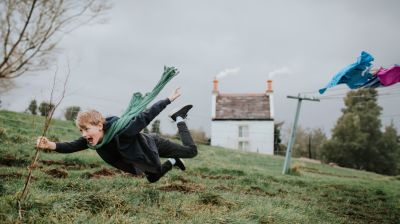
[211,79,274,155]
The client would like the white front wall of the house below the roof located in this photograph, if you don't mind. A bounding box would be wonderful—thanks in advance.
[211,121,274,155]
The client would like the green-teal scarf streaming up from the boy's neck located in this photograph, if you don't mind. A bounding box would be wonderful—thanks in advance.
[88,67,179,149]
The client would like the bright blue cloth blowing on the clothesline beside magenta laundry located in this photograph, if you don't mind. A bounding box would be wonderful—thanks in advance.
[319,51,374,94]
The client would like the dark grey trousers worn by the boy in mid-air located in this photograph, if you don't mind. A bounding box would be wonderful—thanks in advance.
[145,122,197,183]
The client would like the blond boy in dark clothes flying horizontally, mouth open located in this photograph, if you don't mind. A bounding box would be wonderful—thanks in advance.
[37,88,197,183]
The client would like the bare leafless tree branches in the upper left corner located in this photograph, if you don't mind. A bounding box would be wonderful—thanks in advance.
[0,0,110,81]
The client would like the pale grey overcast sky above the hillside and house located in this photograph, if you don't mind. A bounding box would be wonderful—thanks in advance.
[1,0,400,137]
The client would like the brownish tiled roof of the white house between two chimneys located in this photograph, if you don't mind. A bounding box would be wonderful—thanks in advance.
[213,93,272,120]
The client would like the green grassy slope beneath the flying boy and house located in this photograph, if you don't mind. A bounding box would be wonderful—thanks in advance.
[0,111,400,223]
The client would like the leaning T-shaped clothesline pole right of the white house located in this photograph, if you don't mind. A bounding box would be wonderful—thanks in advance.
[282,94,319,174]
